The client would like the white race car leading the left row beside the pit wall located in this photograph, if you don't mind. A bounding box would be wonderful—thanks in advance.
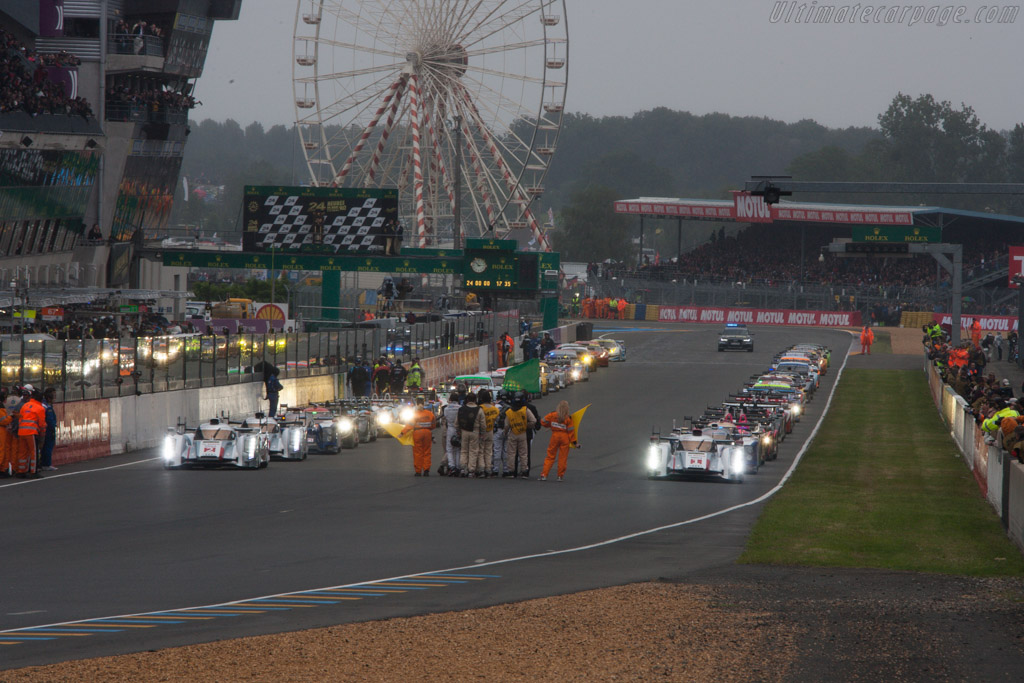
[163,418,270,469]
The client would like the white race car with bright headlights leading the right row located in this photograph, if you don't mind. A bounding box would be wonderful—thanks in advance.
[645,427,746,483]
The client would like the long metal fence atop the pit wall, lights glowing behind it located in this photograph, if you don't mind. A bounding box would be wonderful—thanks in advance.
[6,313,518,401]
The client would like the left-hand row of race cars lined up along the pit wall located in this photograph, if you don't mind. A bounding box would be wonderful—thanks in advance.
[162,339,626,469]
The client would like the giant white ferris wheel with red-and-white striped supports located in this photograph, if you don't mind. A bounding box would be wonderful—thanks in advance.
[292,0,568,250]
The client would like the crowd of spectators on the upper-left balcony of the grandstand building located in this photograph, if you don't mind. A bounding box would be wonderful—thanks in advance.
[0,29,92,119]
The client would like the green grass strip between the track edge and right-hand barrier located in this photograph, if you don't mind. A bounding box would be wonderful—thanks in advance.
[739,368,1024,577]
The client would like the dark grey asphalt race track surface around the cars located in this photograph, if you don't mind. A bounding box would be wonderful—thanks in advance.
[0,323,852,669]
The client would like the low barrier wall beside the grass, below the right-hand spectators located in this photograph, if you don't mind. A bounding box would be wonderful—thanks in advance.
[925,356,1024,551]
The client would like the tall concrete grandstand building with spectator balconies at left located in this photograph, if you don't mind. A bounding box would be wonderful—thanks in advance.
[0,0,242,300]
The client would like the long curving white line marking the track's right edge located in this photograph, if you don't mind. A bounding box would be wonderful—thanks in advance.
[0,340,853,634]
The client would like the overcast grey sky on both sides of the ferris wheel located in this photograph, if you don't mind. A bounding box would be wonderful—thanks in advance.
[193,0,1024,129]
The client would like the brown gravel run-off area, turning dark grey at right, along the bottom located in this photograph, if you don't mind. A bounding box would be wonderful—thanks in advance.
[8,565,1024,682]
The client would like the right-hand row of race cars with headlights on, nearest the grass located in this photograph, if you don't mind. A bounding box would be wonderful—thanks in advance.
[644,341,831,483]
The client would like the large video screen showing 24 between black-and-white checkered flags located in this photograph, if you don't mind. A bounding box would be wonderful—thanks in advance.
[242,185,398,254]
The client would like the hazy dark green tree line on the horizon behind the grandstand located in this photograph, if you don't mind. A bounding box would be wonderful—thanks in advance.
[171,93,1024,261]
